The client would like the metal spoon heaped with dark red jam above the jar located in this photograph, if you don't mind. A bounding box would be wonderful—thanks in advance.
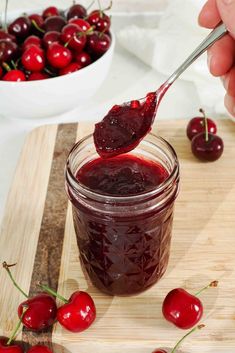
[93,23,227,158]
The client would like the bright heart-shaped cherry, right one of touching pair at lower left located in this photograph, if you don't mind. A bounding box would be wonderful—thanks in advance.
[57,291,96,332]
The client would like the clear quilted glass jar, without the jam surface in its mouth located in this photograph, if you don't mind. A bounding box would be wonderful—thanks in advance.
[65,134,179,295]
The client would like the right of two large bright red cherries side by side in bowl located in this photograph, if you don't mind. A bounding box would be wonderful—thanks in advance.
[47,43,72,69]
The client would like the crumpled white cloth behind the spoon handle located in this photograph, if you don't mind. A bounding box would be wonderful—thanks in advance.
[118,0,227,115]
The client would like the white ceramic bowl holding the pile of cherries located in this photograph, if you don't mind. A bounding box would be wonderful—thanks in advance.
[0,10,115,119]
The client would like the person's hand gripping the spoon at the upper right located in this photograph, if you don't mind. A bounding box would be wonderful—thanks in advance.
[199,0,235,117]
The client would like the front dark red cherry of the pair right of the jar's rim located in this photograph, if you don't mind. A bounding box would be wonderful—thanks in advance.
[191,132,224,162]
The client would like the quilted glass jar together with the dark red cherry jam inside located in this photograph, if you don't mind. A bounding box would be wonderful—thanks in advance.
[65,134,179,295]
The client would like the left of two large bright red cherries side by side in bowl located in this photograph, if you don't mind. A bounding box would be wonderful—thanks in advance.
[21,45,45,72]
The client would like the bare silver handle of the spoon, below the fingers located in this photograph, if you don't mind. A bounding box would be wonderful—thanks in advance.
[165,22,228,85]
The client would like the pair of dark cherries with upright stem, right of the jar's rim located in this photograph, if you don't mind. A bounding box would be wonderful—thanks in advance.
[187,109,224,162]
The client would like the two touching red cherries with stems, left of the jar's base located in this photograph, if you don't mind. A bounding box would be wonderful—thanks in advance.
[3,262,96,332]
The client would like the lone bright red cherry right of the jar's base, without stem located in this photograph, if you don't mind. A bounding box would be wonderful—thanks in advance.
[162,288,203,329]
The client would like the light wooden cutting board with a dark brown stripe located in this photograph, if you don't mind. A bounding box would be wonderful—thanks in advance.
[0,120,235,353]
